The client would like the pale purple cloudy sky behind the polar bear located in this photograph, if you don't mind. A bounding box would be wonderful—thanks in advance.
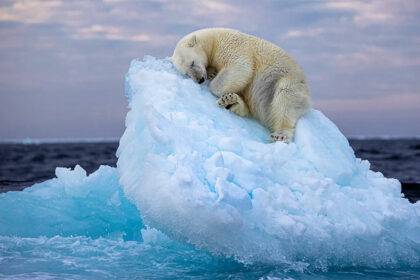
[0,0,420,140]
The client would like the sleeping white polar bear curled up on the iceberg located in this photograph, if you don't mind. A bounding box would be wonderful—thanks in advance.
[171,28,310,142]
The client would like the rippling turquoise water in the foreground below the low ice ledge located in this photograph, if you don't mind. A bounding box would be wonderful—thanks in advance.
[0,229,248,280]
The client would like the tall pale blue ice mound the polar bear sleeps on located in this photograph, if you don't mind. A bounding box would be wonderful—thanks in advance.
[117,57,420,268]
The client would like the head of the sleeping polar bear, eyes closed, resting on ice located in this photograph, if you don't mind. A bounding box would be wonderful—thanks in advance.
[171,35,207,84]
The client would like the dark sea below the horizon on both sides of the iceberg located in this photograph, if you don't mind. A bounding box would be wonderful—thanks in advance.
[0,139,420,201]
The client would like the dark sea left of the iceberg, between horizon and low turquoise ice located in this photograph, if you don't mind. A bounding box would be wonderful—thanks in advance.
[0,142,118,192]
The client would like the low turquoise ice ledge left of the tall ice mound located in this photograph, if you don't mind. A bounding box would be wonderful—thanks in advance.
[0,166,143,240]
